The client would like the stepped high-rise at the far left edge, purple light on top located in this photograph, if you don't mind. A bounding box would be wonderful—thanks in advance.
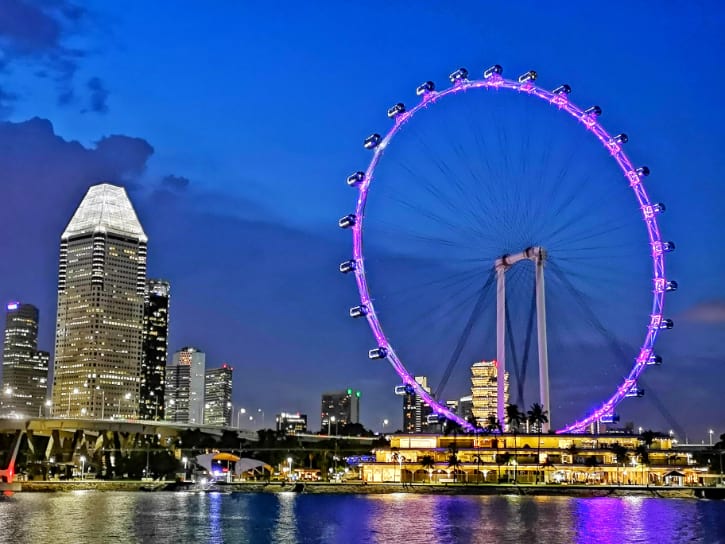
[0,302,50,417]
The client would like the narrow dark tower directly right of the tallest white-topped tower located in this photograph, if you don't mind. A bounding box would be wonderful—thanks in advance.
[139,279,171,420]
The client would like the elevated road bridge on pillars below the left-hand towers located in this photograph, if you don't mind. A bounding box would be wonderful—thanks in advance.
[0,417,258,484]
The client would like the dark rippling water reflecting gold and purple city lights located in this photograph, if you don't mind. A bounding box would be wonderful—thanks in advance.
[0,491,725,544]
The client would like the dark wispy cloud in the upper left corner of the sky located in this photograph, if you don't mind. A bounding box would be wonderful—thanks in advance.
[0,0,108,113]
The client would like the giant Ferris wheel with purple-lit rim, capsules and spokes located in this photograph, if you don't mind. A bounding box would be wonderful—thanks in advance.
[339,65,677,432]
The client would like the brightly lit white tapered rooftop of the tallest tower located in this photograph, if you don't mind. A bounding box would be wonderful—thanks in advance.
[61,183,148,242]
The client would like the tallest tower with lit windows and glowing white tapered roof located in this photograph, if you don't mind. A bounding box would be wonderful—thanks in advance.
[53,183,148,418]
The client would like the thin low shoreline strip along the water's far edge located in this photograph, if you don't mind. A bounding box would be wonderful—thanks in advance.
[12,480,725,500]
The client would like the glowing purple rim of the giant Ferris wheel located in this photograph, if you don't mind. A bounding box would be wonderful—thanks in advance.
[351,73,669,433]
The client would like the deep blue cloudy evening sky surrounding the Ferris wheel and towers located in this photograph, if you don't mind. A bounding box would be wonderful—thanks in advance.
[0,0,725,442]
